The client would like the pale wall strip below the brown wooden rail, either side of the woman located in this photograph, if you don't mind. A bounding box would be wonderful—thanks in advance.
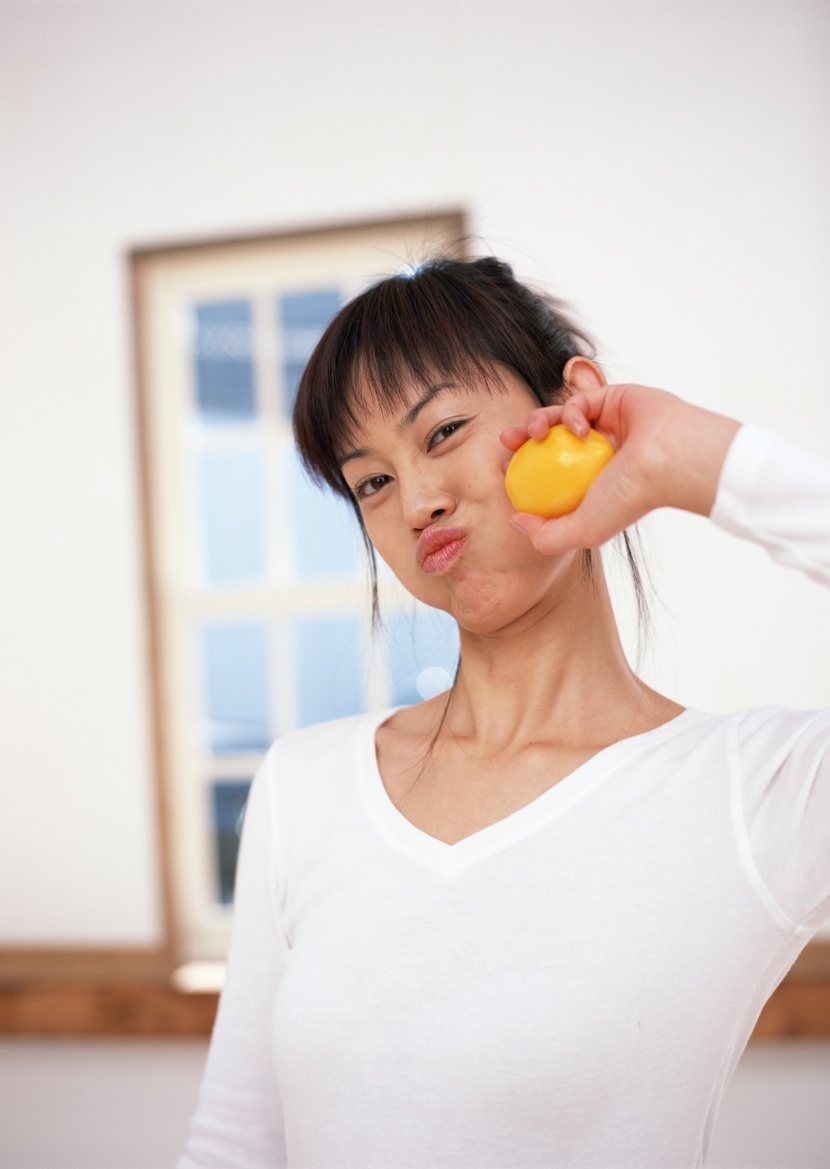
[0,1038,830,1169]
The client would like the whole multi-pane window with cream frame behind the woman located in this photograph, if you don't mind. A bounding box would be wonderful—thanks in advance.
[132,215,463,960]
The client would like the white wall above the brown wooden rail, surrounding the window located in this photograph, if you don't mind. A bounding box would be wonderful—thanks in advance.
[0,0,830,946]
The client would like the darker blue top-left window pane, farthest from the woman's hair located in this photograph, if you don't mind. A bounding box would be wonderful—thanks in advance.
[194,300,255,424]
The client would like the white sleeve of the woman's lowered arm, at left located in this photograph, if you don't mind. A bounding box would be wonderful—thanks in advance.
[177,749,288,1169]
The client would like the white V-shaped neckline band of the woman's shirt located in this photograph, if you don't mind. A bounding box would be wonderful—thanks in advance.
[355,706,705,874]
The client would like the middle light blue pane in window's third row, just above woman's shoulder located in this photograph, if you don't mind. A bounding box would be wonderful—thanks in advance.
[293,617,364,726]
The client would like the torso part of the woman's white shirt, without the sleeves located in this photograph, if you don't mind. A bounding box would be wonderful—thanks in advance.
[272,711,826,1169]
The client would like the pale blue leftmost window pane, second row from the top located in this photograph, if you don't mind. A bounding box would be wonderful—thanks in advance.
[196,450,268,585]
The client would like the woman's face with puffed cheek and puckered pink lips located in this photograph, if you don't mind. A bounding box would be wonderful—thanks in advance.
[341,367,580,634]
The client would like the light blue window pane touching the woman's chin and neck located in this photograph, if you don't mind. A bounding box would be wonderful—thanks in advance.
[383,606,458,706]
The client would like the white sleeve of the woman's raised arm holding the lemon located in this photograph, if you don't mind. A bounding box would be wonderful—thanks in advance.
[711,426,830,932]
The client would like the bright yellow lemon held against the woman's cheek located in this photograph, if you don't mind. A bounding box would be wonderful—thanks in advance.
[504,426,614,519]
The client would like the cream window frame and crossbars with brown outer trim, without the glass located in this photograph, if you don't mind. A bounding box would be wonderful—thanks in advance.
[130,210,464,961]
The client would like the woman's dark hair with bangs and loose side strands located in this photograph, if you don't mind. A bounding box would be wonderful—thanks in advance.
[293,256,646,635]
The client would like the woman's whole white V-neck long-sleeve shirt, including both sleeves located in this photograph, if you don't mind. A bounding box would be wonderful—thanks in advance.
[179,427,830,1169]
